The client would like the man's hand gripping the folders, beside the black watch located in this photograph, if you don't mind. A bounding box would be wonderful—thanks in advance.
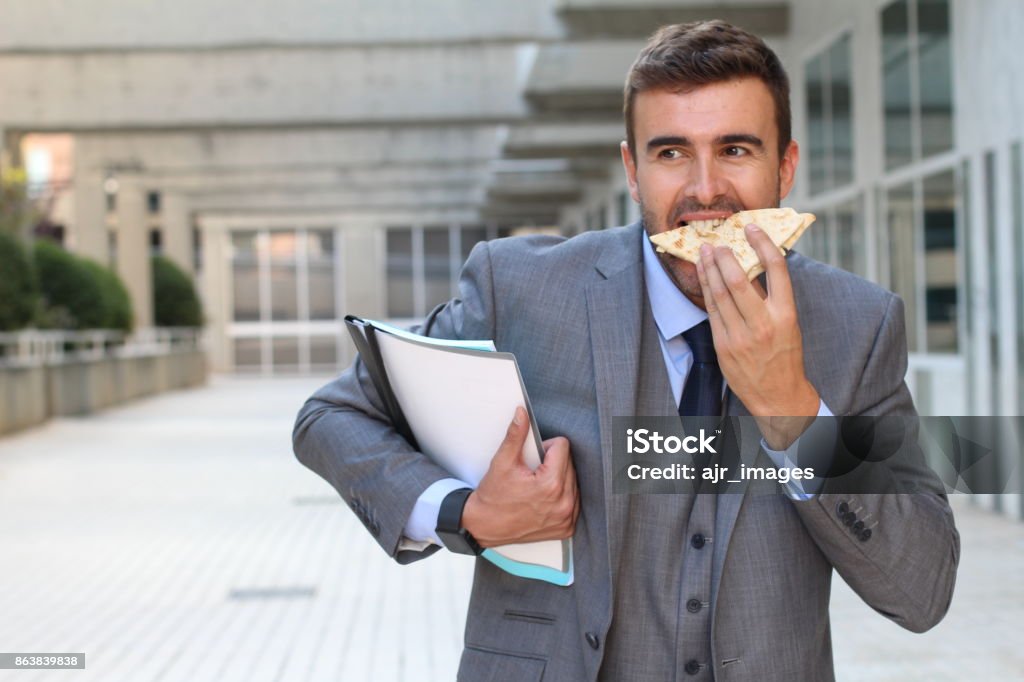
[462,408,580,547]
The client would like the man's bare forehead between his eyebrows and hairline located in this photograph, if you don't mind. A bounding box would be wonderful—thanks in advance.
[633,78,778,147]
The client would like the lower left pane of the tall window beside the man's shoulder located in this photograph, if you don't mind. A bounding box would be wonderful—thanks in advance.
[887,183,921,352]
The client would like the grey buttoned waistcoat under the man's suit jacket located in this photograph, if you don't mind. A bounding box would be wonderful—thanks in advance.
[600,304,716,682]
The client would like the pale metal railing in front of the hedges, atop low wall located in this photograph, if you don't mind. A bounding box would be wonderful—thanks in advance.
[0,327,203,367]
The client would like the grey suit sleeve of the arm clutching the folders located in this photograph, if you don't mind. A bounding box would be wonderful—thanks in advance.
[292,242,495,563]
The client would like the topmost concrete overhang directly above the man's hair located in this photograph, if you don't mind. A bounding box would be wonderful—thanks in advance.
[555,0,790,40]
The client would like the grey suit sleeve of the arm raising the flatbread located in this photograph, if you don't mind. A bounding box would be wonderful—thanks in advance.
[796,296,959,632]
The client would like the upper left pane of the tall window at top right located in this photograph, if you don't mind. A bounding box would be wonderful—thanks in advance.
[882,0,913,168]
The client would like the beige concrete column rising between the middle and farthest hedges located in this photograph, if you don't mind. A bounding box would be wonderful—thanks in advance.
[117,182,153,330]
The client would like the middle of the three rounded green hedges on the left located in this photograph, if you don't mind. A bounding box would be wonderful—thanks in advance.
[35,242,132,332]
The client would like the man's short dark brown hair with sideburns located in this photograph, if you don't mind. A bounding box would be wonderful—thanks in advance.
[623,19,793,158]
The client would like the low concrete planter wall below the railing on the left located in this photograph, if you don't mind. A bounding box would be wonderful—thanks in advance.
[0,350,207,434]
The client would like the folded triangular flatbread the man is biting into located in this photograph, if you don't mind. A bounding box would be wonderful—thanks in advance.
[650,208,815,280]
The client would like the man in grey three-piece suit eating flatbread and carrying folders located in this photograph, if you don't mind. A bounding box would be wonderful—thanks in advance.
[295,22,959,681]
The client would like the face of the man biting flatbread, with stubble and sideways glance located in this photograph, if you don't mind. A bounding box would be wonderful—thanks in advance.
[622,78,800,307]
